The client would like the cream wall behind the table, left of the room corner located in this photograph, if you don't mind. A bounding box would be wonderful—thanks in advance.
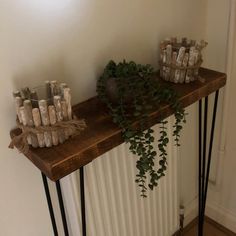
[0,0,209,236]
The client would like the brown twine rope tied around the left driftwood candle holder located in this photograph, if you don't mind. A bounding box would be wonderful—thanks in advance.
[8,116,87,154]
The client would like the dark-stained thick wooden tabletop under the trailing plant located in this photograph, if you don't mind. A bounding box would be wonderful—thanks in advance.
[10,68,226,181]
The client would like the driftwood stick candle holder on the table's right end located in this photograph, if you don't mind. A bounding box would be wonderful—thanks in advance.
[160,37,207,83]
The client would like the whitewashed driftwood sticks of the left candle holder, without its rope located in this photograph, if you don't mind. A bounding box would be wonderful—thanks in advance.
[13,80,75,148]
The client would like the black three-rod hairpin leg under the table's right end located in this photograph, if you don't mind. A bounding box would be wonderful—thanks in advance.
[198,90,219,236]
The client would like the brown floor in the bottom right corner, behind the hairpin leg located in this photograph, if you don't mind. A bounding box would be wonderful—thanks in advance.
[183,218,236,236]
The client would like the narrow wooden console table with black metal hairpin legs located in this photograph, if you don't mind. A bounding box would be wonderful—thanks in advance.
[10,68,226,236]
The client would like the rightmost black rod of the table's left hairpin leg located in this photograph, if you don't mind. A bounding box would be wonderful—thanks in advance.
[80,166,86,236]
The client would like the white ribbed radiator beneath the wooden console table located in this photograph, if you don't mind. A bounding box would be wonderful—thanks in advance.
[62,117,179,236]
